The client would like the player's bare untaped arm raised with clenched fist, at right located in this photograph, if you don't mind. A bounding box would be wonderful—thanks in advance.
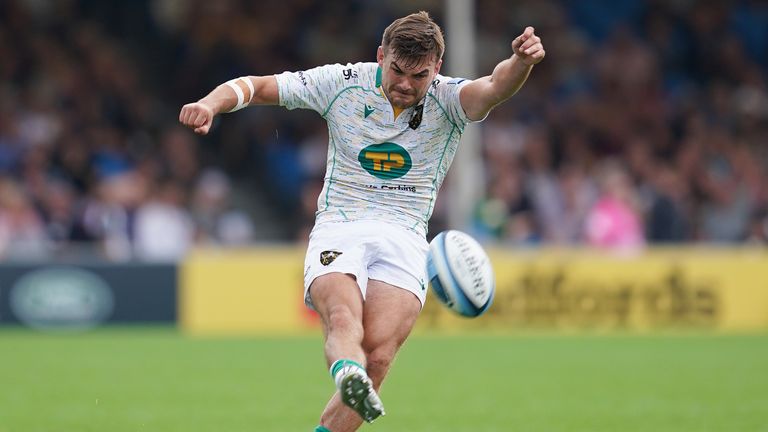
[459,27,545,121]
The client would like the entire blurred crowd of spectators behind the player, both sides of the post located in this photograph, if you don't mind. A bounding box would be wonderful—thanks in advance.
[0,0,768,260]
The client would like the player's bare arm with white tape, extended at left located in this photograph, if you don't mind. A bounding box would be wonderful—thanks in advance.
[179,75,279,135]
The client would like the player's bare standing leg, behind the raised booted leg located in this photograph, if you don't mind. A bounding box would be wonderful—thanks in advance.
[312,280,421,432]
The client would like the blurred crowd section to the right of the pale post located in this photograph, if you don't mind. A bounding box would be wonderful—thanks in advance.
[475,1,768,248]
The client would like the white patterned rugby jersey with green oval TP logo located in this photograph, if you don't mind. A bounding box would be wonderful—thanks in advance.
[275,63,480,235]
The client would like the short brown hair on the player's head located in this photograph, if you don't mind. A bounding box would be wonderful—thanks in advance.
[381,11,445,67]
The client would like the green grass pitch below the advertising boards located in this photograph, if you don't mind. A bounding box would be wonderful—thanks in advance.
[0,328,768,432]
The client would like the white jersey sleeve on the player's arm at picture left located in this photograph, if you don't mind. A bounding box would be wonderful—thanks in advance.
[275,64,358,116]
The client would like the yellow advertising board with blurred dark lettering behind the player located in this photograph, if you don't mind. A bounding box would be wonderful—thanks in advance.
[179,248,768,334]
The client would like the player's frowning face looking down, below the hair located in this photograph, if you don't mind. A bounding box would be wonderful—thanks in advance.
[376,47,443,109]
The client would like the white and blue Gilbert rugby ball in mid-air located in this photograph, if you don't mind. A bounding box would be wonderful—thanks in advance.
[427,230,496,318]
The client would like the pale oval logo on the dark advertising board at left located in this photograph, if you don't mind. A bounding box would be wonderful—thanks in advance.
[9,267,114,330]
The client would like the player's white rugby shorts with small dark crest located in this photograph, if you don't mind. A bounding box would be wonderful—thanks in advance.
[304,220,429,309]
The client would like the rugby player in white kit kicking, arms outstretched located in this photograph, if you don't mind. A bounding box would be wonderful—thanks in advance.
[179,12,545,432]
